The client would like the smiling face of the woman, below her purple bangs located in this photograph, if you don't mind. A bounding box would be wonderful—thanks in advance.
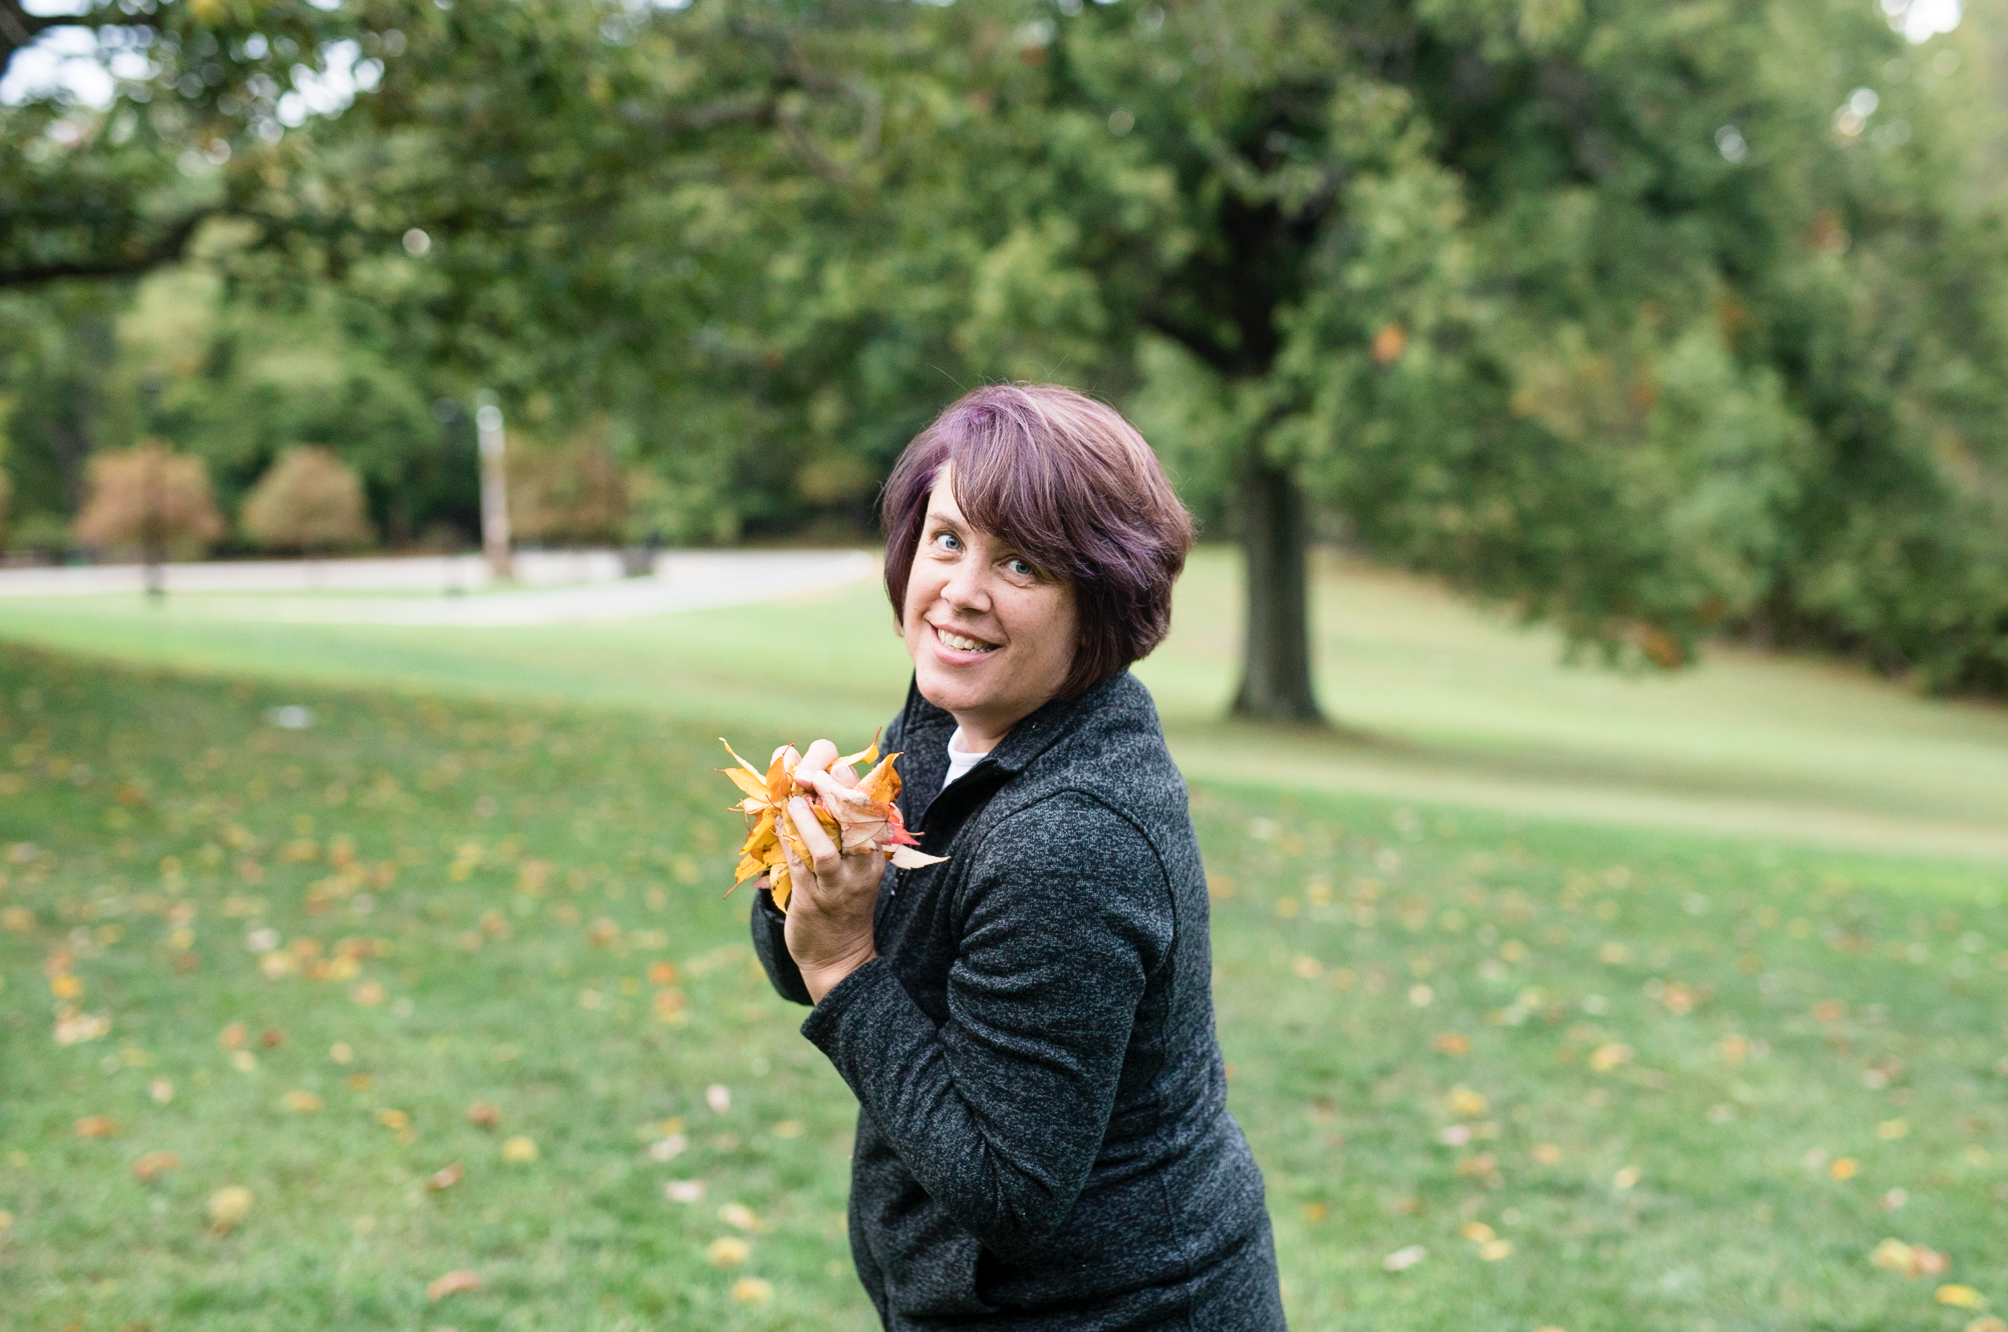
[900,468,1080,751]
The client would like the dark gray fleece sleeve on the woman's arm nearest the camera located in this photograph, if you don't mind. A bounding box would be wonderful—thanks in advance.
[801,794,1173,1256]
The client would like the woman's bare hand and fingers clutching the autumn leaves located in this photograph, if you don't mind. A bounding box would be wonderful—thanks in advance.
[781,739,886,1003]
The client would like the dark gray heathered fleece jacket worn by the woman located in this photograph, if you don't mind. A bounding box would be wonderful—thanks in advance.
[753,671,1283,1332]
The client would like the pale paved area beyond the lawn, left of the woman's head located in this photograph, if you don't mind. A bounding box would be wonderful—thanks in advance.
[0,550,877,627]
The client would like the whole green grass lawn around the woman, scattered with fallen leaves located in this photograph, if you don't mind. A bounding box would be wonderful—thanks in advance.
[0,561,2008,1332]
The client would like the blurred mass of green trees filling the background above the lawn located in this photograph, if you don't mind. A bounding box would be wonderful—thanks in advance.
[0,0,2008,717]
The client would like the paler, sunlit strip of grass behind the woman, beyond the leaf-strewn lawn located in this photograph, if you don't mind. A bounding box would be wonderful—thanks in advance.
[0,550,2008,862]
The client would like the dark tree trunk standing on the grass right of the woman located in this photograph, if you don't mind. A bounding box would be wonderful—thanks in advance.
[1235,444,1323,721]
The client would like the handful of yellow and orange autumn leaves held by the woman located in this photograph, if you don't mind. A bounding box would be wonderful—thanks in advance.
[719,739,948,912]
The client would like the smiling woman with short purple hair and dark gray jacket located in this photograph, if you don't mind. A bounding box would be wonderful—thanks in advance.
[753,386,1283,1332]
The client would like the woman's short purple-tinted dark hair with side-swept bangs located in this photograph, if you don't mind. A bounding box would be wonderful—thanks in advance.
[880,384,1193,697]
